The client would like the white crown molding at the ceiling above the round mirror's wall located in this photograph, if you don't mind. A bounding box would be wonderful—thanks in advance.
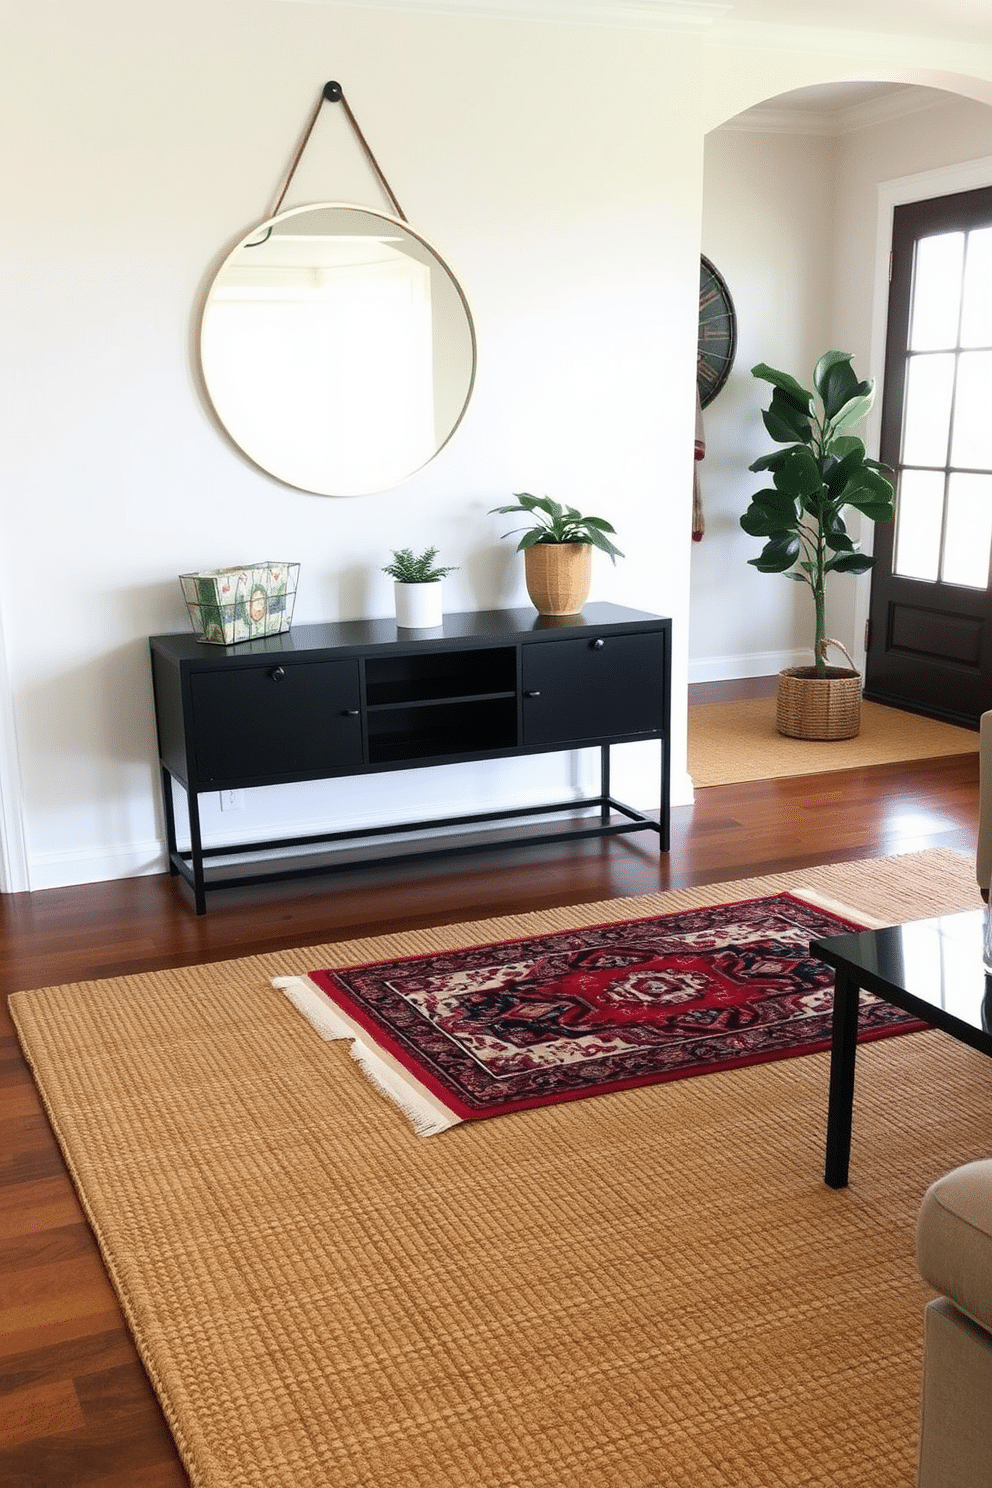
[261,0,733,33]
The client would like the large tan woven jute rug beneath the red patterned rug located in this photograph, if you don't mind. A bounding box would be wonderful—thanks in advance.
[10,851,992,1488]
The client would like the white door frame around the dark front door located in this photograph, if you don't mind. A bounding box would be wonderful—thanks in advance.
[854,155,992,676]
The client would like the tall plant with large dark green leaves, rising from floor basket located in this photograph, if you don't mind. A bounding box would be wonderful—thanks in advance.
[741,351,894,677]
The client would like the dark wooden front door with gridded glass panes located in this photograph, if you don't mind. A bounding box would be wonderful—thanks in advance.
[864,187,992,723]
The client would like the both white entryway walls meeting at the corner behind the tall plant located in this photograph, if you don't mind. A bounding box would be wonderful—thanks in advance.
[689,94,992,680]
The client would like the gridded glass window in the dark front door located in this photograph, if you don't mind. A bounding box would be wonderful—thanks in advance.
[892,226,992,589]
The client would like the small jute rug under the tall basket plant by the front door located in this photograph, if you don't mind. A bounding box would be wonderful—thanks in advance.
[689,698,979,786]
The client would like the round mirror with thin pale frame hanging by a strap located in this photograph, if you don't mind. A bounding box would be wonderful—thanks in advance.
[199,202,476,496]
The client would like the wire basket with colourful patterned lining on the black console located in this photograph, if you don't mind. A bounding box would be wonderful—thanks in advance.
[178,562,299,646]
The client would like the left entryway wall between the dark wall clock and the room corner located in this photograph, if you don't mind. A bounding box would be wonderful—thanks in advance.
[689,129,834,682]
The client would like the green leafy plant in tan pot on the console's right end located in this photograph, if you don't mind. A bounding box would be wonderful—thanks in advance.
[491,491,623,615]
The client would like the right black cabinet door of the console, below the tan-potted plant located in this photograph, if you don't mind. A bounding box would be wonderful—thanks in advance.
[521,631,666,745]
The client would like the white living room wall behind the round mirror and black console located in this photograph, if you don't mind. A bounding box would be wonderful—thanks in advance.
[0,0,992,888]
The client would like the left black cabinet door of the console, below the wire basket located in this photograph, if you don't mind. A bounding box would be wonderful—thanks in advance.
[189,659,361,790]
